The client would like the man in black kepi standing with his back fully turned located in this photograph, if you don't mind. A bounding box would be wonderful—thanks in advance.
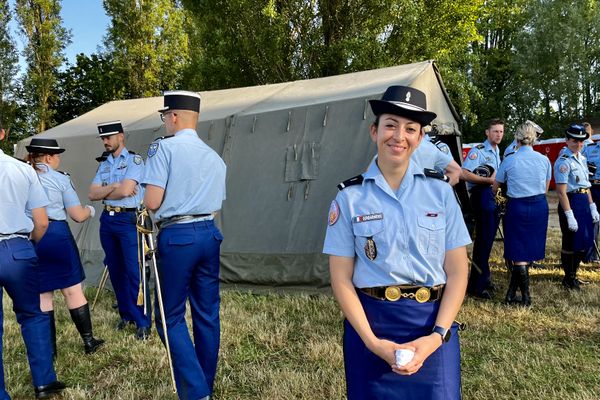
[142,91,226,400]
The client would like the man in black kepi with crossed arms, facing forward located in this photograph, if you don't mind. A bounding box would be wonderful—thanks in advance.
[89,121,151,340]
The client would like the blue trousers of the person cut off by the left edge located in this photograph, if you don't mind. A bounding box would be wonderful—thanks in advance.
[0,238,56,400]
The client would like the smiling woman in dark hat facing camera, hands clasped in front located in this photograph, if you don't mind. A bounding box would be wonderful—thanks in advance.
[323,86,470,400]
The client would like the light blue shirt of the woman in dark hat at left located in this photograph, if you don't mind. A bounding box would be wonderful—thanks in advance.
[36,163,81,221]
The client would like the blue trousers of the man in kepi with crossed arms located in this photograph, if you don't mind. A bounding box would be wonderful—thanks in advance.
[100,211,150,328]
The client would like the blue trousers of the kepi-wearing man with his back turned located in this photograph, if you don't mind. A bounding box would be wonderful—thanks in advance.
[155,221,223,400]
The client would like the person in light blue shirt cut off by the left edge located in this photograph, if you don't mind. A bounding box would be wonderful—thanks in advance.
[0,124,66,400]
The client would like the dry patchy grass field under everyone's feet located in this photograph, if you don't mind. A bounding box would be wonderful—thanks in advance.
[4,230,600,400]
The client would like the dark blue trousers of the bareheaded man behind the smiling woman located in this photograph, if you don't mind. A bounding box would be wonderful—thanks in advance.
[468,186,500,293]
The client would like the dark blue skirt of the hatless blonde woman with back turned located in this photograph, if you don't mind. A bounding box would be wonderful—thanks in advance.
[504,194,548,262]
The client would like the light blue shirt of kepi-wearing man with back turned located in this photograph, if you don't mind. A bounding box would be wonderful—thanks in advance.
[142,129,226,221]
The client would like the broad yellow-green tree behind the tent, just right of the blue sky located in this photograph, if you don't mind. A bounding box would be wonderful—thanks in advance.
[104,0,189,97]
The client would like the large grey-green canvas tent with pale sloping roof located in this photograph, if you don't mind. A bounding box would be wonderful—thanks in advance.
[17,61,460,286]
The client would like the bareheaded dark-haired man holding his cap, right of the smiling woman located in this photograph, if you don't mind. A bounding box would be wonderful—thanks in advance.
[461,119,504,299]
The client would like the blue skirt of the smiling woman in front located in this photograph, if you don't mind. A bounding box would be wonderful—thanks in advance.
[344,291,461,400]
